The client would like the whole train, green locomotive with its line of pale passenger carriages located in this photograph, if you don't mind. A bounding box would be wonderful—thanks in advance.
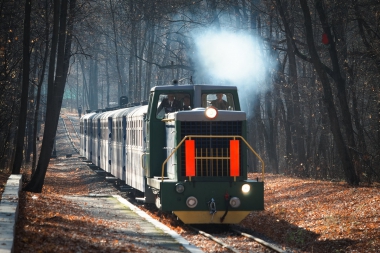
[80,84,264,224]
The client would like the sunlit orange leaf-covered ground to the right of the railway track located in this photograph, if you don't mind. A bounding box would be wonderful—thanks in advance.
[242,174,380,252]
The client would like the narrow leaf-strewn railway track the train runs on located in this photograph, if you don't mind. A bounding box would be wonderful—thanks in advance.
[61,114,290,253]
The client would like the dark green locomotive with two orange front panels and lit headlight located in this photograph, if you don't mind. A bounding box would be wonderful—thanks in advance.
[144,85,264,223]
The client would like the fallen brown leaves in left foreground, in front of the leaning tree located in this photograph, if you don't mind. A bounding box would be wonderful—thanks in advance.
[14,192,145,253]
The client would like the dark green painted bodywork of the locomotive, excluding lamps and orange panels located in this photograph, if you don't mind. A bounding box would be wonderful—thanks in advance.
[144,85,264,214]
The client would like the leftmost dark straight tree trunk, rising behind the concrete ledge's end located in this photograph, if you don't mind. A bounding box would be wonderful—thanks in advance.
[12,0,32,174]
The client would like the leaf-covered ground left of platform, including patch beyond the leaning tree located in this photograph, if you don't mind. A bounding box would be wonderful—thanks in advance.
[14,165,149,253]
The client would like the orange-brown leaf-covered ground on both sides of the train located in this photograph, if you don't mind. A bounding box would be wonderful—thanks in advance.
[0,166,380,253]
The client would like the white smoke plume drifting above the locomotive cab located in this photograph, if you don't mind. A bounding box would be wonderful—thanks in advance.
[192,29,273,113]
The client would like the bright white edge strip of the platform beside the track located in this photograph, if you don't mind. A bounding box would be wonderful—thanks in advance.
[112,195,203,253]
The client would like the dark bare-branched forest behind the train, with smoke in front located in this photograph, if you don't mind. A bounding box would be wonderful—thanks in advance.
[0,0,380,187]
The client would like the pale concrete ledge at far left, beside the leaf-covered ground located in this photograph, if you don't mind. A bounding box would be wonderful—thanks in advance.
[0,174,22,253]
